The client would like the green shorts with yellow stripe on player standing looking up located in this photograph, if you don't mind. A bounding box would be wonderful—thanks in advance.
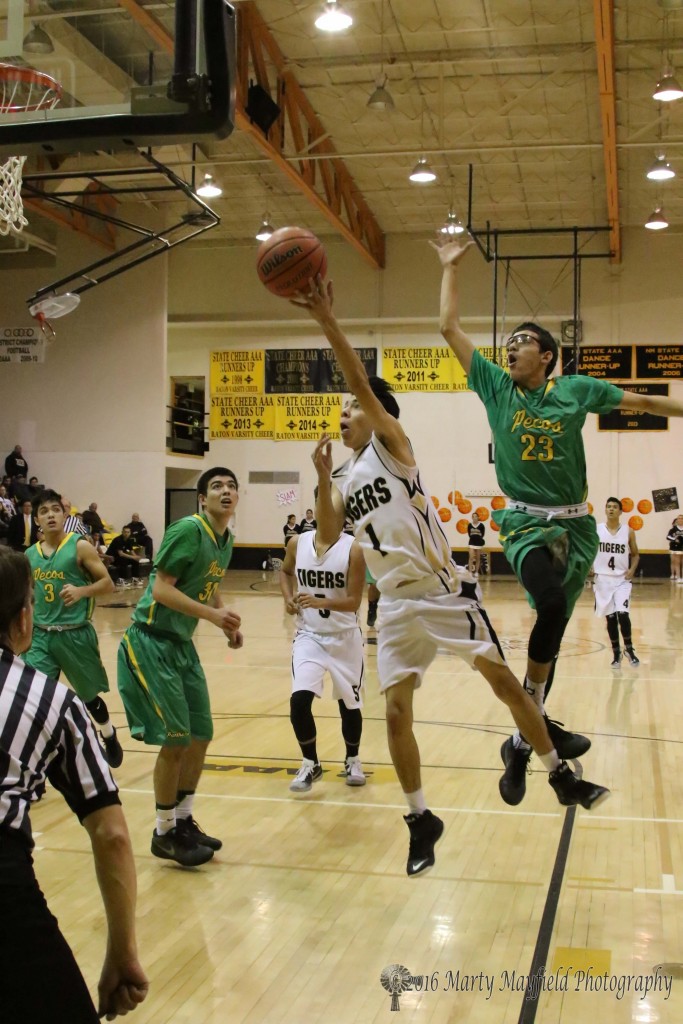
[118,625,213,746]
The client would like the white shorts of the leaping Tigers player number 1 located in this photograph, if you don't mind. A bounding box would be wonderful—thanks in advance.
[377,575,505,693]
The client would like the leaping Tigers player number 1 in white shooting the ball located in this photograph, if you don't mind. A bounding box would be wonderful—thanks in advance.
[294,276,607,876]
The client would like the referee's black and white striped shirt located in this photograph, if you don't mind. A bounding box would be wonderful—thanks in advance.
[0,647,121,847]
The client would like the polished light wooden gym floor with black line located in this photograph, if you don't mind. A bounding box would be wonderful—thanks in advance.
[32,572,683,1024]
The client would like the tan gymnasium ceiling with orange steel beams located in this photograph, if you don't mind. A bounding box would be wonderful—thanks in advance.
[5,0,683,262]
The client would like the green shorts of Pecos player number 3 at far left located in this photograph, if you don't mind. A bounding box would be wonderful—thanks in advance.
[24,623,110,703]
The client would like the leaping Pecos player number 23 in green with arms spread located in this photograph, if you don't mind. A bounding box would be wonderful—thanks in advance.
[432,235,683,804]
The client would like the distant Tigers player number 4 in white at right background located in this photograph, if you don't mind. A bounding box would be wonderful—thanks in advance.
[593,498,640,669]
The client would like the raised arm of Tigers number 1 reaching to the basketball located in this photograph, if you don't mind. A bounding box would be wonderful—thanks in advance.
[291,274,415,466]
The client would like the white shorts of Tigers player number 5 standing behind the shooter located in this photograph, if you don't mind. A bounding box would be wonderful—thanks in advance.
[292,628,365,711]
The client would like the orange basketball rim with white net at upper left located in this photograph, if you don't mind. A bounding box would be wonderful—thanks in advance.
[0,63,61,234]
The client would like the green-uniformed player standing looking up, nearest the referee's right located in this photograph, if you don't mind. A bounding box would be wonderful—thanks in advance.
[118,466,243,867]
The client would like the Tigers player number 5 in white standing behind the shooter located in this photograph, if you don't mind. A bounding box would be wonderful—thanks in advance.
[280,530,366,793]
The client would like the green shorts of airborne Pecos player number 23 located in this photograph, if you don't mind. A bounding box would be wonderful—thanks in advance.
[493,509,599,617]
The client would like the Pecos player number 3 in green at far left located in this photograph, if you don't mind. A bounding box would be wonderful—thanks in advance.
[24,489,123,768]
